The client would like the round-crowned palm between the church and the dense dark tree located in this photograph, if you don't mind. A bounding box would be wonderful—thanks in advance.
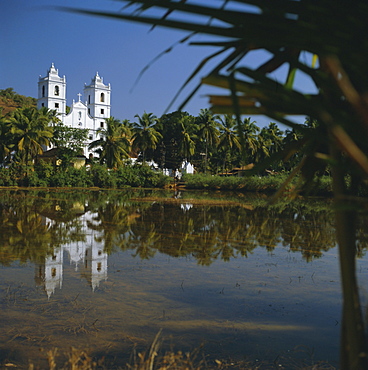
[132,112,162,163]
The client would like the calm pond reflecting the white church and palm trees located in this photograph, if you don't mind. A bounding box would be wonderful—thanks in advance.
[0,190,368,369]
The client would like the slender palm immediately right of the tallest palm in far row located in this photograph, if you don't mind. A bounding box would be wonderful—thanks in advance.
[218,114,241,170]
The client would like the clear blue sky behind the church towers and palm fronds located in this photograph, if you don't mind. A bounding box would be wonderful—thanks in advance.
[0,0,312,126]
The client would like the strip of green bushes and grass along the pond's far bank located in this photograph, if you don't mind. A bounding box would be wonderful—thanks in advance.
[0,162,332,196]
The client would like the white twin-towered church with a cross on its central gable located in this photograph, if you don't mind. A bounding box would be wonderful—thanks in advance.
[37,63,111,158]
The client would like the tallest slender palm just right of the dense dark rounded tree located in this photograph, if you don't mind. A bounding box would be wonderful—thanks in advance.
[197,109,219,173]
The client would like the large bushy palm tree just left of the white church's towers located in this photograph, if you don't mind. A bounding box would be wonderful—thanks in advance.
[9,107,53,165]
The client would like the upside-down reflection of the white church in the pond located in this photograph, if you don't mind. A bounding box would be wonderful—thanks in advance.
[35,212,107,298]
